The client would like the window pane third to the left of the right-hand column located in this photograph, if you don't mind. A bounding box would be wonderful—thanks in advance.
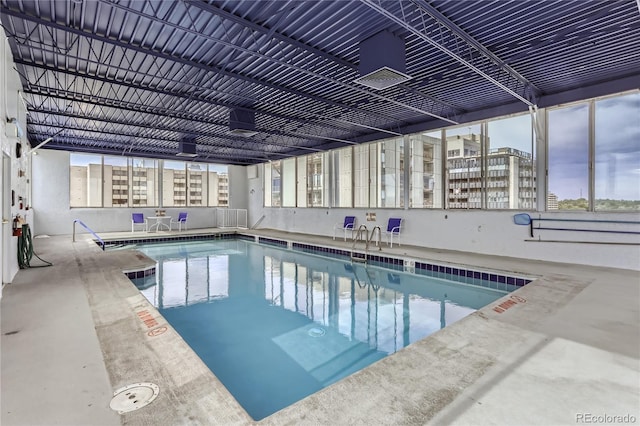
[409,131,442,208]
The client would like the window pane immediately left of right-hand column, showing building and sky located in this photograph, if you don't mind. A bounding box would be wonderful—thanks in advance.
[486,114,536,210]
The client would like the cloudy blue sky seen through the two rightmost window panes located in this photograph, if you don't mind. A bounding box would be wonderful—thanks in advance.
[548,93,640,200]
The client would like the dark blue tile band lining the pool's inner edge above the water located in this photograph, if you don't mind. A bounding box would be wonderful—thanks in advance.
[104,232,533,290]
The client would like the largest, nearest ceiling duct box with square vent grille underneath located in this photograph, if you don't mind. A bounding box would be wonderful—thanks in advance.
[354,31,411,90]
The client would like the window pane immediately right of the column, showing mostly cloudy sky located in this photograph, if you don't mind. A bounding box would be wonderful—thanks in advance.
[547,104,589,210]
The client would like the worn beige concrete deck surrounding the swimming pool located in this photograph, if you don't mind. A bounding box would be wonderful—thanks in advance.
[0,229,640,425]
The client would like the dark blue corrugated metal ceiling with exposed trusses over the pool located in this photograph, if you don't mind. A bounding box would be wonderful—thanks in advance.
[0,0,640,165]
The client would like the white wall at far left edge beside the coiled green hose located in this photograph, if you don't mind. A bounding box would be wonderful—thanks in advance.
[0,31,33,288]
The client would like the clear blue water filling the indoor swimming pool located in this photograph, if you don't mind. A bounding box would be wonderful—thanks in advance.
[132,240,517,420]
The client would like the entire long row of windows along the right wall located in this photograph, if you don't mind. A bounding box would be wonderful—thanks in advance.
[265,91,640,211]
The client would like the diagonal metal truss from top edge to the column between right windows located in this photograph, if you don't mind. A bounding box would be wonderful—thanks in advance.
[360,0,540,107]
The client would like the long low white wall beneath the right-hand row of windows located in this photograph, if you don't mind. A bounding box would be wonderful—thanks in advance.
[248,165,640,270]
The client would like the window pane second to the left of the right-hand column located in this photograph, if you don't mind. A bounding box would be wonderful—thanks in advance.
[445,124,484,209]
